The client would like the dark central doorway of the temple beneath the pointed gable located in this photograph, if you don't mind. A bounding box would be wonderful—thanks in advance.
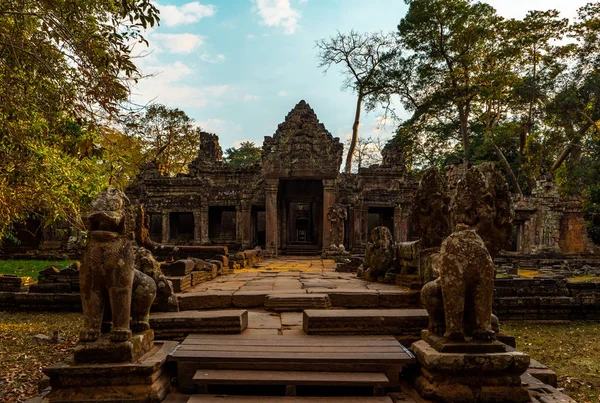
[279,179,323,253]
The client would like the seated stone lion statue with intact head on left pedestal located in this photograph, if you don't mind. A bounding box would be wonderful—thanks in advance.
[79,187,156,342]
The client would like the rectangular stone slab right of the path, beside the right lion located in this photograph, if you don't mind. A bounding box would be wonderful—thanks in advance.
[302,309,429,338]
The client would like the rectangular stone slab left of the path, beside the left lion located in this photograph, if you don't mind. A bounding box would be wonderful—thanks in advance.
[150,309,248,340]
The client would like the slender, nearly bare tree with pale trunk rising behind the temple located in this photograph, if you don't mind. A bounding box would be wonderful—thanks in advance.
[316,31,399,173]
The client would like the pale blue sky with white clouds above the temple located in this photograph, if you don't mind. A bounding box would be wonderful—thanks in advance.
[132,0,587,149]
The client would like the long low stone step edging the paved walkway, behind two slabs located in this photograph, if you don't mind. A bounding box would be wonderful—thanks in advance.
[177,288,420,311]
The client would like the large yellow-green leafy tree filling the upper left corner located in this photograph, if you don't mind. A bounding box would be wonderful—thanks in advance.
[0,0,158,239]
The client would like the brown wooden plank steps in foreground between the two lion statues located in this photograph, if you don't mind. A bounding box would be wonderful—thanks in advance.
[169,334,415,401]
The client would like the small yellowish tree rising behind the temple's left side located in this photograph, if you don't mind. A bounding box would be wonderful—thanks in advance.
[125,104,200,176]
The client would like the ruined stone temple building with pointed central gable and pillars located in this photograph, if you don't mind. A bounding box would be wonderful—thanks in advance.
[128,101,418,255]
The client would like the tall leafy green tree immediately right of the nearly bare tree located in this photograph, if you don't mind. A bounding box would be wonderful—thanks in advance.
[398,0,502,159]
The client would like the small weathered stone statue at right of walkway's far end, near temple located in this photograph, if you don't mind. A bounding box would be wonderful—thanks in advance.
[363,226,395,281]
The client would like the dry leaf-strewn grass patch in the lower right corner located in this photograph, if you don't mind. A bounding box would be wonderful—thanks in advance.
[502,322,600,403]
